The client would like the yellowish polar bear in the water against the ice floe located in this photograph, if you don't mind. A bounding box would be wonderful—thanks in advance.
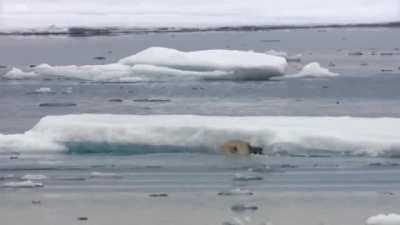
[220,140,263,155]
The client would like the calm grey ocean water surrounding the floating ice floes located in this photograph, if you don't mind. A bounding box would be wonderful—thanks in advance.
[0,28,400,225]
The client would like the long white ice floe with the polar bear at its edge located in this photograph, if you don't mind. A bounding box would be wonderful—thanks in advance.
[0,114,400,157]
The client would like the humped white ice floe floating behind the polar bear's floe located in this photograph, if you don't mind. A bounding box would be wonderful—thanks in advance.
[5,47,287,82]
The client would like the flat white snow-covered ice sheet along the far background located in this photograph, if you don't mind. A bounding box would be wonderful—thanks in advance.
[0,0,400,35]
